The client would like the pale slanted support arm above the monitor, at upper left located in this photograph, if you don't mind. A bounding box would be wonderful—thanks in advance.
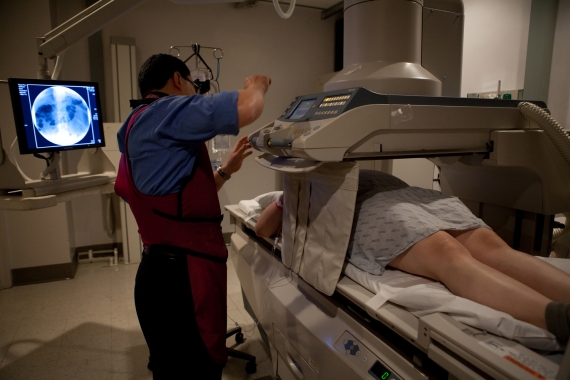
[37,0,146,79]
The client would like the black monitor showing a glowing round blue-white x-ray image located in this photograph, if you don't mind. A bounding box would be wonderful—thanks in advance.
[8,78,105,154]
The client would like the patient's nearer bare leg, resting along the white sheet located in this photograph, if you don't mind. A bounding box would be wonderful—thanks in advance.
[390,231,551,328]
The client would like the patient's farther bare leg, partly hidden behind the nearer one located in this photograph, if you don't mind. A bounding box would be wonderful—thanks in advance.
[447,228,570,303]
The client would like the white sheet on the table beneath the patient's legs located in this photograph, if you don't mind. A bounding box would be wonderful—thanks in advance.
[344,264,561,350]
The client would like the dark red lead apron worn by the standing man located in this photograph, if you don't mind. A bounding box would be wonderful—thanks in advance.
[115,107,228,365]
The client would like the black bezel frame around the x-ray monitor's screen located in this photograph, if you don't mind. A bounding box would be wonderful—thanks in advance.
[8,78,105,154]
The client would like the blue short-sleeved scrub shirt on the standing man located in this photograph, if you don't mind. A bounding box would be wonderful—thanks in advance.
[117,91,239,196]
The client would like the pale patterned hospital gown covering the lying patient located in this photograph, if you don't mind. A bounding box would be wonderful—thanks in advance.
[347,170,490,275]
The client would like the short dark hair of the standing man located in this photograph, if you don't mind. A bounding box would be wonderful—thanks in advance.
[139,54,190,98]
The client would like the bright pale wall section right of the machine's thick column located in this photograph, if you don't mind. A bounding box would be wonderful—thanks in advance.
[461,0,531,96]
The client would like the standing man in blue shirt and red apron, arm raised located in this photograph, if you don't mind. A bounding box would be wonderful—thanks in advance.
[115,54,271,379]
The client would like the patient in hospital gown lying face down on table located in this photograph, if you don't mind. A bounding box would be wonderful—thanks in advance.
[255,170,570,345]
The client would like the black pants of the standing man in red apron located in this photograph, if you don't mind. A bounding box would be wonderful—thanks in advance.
[135,252,223,380]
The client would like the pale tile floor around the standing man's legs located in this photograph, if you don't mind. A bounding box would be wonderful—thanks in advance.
[0,254,272,380]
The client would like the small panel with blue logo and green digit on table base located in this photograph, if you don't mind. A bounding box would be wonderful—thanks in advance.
[334,331,401,380]
